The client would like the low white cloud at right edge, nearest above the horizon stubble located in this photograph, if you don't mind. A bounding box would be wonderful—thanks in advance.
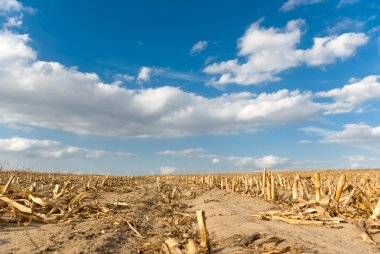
[322,123,380,150]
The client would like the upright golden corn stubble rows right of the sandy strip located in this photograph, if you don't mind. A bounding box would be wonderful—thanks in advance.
[193,168,380,248]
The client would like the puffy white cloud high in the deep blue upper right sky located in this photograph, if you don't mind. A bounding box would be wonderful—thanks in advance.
[204,20,368,86]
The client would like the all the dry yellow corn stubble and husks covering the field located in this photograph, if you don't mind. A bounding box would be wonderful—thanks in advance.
[0,169,380,253]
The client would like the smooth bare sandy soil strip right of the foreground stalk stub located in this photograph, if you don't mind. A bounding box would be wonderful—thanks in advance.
[187,189,380,254]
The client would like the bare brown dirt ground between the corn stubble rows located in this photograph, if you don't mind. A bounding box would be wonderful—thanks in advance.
[0,179,380,254]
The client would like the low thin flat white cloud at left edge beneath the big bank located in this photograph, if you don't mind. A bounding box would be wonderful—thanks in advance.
[0,137,131,158]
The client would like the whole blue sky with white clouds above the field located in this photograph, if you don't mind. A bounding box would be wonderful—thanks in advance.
[0,0,380,175]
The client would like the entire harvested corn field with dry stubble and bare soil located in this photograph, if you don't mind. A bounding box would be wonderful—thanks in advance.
[0,170,380,253]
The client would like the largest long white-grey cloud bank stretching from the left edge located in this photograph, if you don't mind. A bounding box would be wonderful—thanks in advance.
[0,31,330,138]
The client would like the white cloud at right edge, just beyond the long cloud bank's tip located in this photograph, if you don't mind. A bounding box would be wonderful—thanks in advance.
[317,75,380,114]
